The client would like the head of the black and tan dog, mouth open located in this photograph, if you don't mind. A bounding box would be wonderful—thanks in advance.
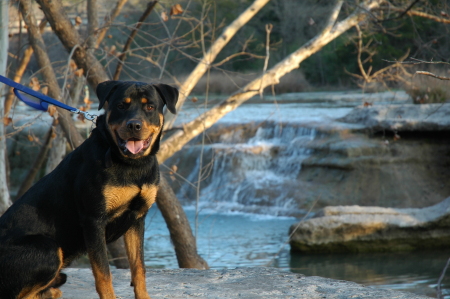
[97,81,178,159]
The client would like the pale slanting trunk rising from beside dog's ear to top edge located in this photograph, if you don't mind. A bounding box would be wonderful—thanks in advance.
[164,0,270,130]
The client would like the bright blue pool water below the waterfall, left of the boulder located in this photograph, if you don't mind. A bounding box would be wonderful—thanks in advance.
[145,207,296,269]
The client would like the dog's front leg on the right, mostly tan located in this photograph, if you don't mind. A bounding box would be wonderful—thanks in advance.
[124,216,150,299]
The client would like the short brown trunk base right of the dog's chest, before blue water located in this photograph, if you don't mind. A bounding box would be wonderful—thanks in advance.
[156,176,209,269]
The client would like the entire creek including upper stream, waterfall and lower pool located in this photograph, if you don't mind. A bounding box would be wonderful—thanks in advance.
[145,93,450,298]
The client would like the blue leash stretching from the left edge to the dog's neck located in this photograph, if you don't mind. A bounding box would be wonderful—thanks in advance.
[0,75,97,121]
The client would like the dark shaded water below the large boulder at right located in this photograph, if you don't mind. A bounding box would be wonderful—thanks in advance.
[289,250,450,298]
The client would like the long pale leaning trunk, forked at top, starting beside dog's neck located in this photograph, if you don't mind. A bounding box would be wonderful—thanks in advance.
[158,0,383,163]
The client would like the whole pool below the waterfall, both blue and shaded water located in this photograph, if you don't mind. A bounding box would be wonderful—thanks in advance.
[145,207,450,298]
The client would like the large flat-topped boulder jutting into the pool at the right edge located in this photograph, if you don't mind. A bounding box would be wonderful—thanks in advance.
[290,197,450,252]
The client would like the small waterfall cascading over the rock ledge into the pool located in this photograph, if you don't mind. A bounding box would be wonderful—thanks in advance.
[172,122,316,215]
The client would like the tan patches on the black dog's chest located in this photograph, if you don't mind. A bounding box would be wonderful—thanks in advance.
[103,184,158,218]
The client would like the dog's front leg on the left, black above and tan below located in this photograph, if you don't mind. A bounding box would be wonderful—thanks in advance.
[83,219,116,299]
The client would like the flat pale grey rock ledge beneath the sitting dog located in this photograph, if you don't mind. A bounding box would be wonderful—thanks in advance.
[61,268,430,299]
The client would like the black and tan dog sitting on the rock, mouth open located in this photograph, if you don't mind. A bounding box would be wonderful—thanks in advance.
[0,81,178,299]
